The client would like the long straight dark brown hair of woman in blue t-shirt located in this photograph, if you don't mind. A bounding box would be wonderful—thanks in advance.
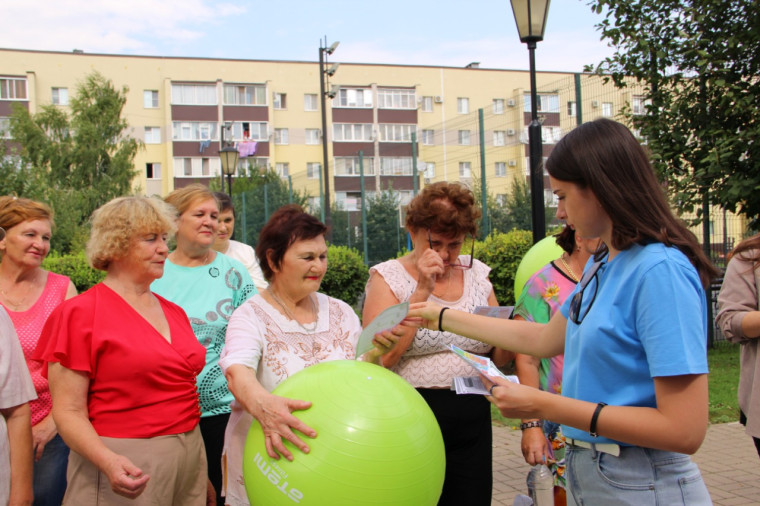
[546,118,718,288]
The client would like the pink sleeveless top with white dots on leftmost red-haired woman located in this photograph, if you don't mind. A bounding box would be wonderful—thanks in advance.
[4,272,70,426]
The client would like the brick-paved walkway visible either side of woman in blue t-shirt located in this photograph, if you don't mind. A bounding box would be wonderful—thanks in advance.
[491,422,760,506]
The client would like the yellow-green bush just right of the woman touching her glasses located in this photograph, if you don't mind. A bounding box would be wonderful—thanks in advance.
[475,230,533,306]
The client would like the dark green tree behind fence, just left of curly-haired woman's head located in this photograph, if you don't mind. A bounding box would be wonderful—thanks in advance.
[366,188,405,265]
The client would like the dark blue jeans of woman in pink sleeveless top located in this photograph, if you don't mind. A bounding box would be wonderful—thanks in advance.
[34,434,69,506]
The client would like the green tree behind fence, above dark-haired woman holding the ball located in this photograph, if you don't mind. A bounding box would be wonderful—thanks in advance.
[229,166,309,246]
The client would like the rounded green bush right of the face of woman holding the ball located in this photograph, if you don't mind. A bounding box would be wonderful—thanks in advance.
[320,244,369,306]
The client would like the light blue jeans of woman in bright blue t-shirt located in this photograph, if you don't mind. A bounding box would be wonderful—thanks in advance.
[566,446,712,506]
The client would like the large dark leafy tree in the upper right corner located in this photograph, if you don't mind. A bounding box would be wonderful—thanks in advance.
[587,0,760,226]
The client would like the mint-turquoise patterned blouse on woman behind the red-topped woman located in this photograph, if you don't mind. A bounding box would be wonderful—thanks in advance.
[150,253,256,417]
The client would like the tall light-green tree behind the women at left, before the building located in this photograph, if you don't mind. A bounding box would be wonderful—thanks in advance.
[3,72,142,253]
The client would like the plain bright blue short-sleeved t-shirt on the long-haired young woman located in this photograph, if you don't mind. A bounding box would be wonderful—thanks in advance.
[560,243,707,444]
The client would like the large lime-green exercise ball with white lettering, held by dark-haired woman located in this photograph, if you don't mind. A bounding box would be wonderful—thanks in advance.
[243,360,446,506]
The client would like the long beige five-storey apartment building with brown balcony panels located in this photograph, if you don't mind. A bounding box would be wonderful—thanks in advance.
[0,49,643,210]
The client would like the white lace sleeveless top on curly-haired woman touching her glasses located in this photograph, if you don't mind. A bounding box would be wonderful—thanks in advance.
[370,255,493,388]
